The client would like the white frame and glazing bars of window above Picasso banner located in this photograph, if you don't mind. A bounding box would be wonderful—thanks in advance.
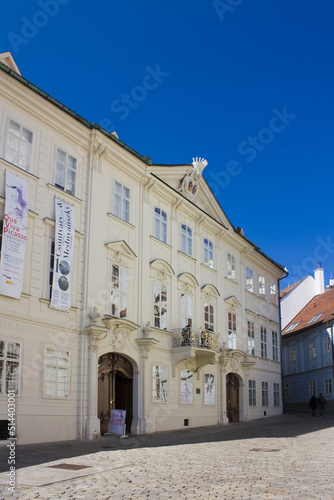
[4,118,34,172]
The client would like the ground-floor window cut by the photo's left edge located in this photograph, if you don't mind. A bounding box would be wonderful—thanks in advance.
[0,340,21,394]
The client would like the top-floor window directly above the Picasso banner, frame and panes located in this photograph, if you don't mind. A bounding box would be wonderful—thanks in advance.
[5,120,33,172]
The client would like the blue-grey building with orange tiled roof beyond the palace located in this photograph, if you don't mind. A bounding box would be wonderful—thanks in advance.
[282,274,334,411]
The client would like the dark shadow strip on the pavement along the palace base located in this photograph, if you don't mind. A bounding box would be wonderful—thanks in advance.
[0,414,334,472]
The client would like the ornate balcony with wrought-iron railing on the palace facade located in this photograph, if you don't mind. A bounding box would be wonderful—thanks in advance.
[172,327,218,376]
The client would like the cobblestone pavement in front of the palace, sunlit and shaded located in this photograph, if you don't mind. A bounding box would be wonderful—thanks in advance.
[0,414,334,500]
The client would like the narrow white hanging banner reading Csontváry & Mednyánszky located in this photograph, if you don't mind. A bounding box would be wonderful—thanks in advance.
[50,198,75,311]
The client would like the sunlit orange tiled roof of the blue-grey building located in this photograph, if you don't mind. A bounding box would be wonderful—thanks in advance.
[282,288,334,336]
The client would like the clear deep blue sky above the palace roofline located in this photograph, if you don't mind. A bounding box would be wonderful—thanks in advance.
[0,0,334,287]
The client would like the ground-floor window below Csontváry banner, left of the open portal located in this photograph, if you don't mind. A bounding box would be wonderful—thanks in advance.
[44,347,70,399]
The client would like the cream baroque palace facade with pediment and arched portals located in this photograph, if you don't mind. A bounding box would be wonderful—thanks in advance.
[0,53,286,444]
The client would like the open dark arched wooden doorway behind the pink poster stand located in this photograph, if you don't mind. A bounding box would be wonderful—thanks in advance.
[98,352,133,436]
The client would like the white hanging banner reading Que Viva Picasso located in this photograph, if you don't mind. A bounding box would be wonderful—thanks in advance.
[0,171,28,299]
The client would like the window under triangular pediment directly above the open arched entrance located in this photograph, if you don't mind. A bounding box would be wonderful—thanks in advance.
[110,264,128,318]
